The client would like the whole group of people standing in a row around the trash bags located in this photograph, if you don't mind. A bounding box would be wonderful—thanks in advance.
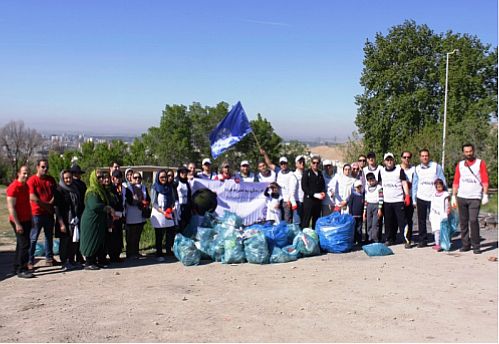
[7,144,488,278]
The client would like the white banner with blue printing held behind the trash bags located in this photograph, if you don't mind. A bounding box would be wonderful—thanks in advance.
[191,178,269,225]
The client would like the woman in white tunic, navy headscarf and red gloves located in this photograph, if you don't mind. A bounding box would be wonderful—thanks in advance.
[151,169,176,262]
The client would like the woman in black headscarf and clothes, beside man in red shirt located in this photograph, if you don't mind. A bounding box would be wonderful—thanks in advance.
[55,170,83,270]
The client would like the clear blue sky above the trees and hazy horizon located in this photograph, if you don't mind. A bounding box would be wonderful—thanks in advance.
[0,0,498,141]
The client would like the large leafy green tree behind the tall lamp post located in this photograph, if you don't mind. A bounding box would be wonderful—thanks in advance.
[355,21,497,175]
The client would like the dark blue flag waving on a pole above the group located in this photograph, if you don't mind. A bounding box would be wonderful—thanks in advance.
[210,102,251,159]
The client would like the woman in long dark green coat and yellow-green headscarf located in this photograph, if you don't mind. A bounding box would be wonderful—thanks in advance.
[80,171,114,270]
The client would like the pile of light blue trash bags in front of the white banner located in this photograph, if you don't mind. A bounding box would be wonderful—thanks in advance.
[173,212,321,266]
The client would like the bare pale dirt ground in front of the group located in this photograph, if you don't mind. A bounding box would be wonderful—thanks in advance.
[0,224,498,342]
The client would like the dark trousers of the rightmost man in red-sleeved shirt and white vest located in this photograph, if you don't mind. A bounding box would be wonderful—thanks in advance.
[457,197,481,249]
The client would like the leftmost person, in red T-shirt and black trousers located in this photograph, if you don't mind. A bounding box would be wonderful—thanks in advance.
[7,166,35,278]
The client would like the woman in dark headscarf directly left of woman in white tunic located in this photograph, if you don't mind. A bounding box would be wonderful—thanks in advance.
[125,172,151,258]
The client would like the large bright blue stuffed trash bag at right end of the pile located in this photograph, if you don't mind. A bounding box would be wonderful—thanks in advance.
[315,213,355,253]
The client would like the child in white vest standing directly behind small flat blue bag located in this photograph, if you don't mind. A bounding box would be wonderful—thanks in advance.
[363,172,383,242]
